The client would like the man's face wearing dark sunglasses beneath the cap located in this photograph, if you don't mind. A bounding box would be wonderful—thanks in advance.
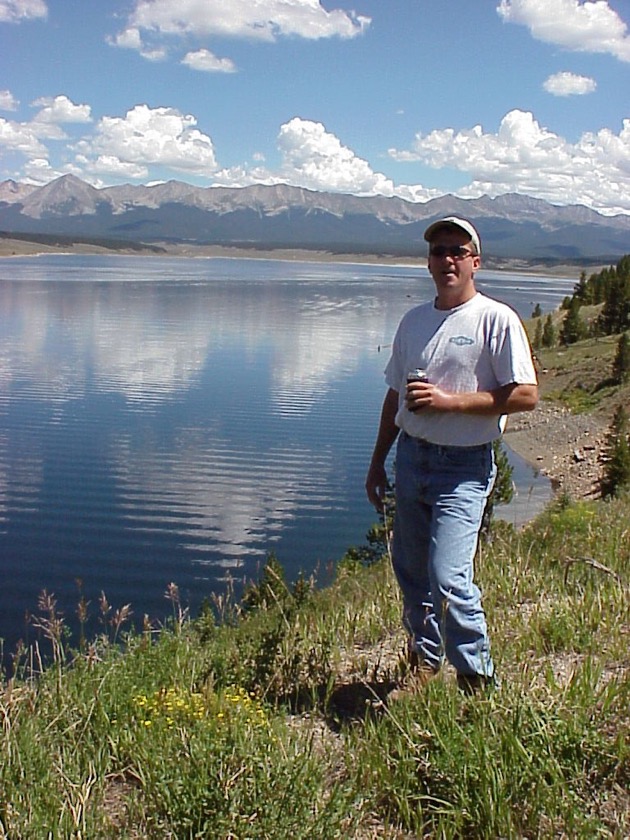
[429,228,481,303]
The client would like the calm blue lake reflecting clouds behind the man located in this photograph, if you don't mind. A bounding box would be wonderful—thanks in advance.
[0,255,577,649]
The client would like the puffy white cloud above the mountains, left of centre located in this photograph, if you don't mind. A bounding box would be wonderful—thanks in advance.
[77,105,216,177]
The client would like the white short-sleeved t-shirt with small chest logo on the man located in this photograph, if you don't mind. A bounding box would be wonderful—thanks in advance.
[385,292,537,446]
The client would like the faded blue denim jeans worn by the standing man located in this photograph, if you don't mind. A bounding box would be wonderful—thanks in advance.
[393,432,496,677]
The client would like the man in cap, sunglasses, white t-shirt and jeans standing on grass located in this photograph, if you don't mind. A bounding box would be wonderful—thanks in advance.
[365,217,538,692]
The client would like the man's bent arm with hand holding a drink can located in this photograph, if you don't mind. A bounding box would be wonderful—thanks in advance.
[406,382,538,414]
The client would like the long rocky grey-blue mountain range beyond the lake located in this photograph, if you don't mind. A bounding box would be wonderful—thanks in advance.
[0,175,630,262]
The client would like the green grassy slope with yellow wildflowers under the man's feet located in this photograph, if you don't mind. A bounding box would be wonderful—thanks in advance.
[0,496,630,840]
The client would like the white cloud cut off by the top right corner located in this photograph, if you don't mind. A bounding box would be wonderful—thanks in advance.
[497,0,630,61]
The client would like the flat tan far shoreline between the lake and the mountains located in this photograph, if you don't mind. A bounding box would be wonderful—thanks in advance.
[0,238,596,281]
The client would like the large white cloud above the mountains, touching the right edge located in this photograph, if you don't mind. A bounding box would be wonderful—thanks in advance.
[390,110,630,214]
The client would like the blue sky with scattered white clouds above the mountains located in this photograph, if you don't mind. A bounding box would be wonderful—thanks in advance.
[0,0,630,214]
